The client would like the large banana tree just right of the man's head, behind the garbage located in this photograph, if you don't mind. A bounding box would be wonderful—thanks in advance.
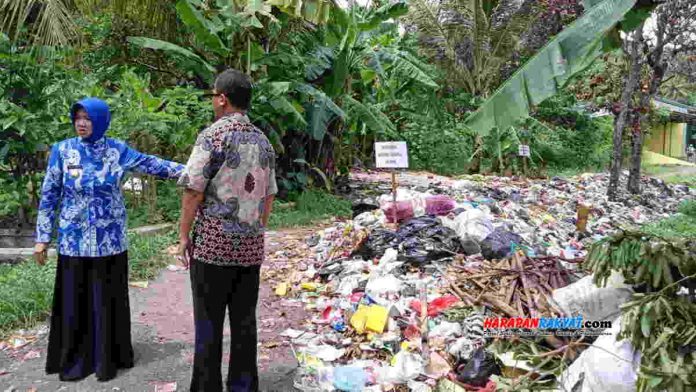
[294,3,438,174]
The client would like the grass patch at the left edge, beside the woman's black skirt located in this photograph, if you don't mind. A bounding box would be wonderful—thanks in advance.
[0,260,56,338]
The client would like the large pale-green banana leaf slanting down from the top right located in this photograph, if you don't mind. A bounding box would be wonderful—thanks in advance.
[465,0,636,136]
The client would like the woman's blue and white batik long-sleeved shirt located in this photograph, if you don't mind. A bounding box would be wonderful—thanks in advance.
[36,138,184,257]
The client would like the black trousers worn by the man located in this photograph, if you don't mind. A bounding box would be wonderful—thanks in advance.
[190,260,260,392]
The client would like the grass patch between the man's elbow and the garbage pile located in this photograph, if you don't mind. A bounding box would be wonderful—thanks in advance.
[268,190,352,229]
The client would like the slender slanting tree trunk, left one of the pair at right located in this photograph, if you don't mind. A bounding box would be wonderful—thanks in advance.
[607,25,643,201]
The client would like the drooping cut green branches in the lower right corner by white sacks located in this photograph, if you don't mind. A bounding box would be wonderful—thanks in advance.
[585,225,696,391]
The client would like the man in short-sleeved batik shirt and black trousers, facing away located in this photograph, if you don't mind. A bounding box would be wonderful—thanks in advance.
[179,70,277,392]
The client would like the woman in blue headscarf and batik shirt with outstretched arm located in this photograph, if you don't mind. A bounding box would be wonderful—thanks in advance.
[34,98,184,381]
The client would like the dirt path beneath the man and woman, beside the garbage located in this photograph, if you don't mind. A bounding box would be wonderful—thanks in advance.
[0,228,316,392]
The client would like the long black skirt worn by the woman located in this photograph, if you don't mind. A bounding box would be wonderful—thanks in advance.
[46,252,133,381]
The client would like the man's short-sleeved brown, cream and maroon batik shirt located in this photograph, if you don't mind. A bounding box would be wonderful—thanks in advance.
[179,113,278,265]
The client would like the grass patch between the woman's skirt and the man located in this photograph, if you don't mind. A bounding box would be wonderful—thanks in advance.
[128,230,178,281]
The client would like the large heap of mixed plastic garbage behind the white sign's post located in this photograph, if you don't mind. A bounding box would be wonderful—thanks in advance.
[277,174,694,392]
